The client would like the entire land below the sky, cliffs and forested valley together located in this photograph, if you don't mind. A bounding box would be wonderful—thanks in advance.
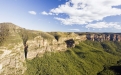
[0,23,121,75]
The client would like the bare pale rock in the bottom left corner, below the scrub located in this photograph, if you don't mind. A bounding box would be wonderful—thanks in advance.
[0,43,26,75]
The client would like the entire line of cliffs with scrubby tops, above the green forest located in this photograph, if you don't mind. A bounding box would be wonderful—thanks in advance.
[0,23,121,75]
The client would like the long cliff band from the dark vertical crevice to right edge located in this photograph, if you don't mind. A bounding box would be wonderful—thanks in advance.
[27,33,121,59]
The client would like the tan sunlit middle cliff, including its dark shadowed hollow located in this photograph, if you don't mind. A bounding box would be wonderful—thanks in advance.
[26,35,86,59]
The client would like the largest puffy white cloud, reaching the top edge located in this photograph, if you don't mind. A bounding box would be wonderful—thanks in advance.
[42,0,121,25]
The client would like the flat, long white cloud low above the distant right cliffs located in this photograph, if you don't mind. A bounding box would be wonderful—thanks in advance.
[86,22,121,29]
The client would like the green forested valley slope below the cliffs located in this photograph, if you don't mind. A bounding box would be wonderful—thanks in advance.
[25,41,121,75]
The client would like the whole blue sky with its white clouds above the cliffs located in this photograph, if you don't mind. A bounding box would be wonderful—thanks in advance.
[0,0,121,32]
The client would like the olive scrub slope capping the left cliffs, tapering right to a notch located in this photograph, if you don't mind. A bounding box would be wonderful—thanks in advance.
[0,23,54,46]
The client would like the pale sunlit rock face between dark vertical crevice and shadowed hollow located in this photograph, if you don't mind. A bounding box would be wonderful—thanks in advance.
[27,36,67,59]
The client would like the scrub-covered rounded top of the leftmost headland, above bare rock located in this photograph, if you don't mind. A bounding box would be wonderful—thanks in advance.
[0,23,21,48]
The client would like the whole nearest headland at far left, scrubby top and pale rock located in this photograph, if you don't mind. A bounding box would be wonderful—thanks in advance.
[0,23,26,75]
